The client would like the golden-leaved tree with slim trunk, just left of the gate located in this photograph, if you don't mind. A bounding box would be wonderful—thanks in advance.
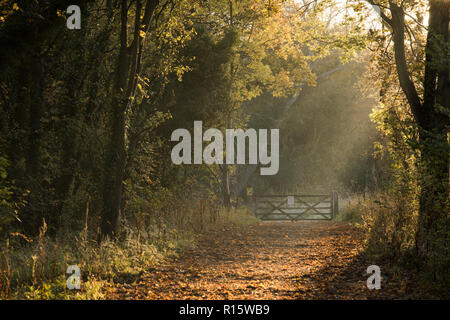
[188,0,332,207]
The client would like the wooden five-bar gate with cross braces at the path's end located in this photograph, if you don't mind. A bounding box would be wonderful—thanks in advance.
[253,192,339,221]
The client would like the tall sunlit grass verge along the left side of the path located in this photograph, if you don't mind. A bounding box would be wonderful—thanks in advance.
[0,194,256,299]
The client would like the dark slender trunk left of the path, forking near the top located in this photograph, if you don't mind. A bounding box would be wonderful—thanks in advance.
[101,0,159,238]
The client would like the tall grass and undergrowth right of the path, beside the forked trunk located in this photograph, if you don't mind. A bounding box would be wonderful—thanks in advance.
[337,192,450,297]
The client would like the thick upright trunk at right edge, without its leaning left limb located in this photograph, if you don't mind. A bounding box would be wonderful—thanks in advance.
[416,0,450,276]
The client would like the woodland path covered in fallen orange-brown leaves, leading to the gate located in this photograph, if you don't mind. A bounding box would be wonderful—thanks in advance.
[107,221,446,299]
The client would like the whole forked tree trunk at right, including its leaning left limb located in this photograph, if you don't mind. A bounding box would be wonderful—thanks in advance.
[368,0,450,276]
